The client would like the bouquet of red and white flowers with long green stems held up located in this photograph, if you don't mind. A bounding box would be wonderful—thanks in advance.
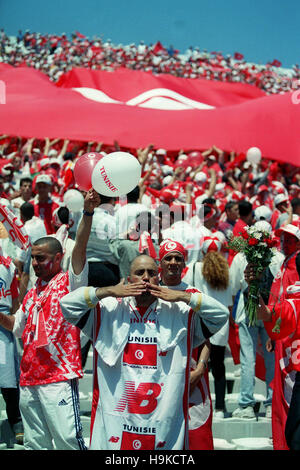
[228,225,276,326]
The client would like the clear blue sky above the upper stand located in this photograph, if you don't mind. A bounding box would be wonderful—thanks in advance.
[0,0,300,67]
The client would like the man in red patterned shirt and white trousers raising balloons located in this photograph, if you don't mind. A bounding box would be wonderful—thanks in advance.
[0,190,100,450]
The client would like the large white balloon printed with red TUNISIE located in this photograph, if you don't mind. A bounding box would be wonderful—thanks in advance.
[92,152,141,197]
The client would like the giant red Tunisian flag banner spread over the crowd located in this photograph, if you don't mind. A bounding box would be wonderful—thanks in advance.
[0,64,300,164]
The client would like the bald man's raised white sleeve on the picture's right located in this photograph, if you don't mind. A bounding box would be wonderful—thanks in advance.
[189,293,229,347]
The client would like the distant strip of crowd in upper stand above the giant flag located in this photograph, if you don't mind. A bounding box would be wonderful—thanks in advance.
[0,29,300,94]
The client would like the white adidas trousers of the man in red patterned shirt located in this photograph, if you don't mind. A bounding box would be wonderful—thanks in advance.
[20,379,86,450]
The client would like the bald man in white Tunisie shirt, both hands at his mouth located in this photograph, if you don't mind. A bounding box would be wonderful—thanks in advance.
[61,255,227,450]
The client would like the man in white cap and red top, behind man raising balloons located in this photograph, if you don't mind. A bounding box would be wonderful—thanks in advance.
[29,174,59,235]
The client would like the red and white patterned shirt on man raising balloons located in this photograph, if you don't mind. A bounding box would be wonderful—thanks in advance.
[17,272,83,386]
